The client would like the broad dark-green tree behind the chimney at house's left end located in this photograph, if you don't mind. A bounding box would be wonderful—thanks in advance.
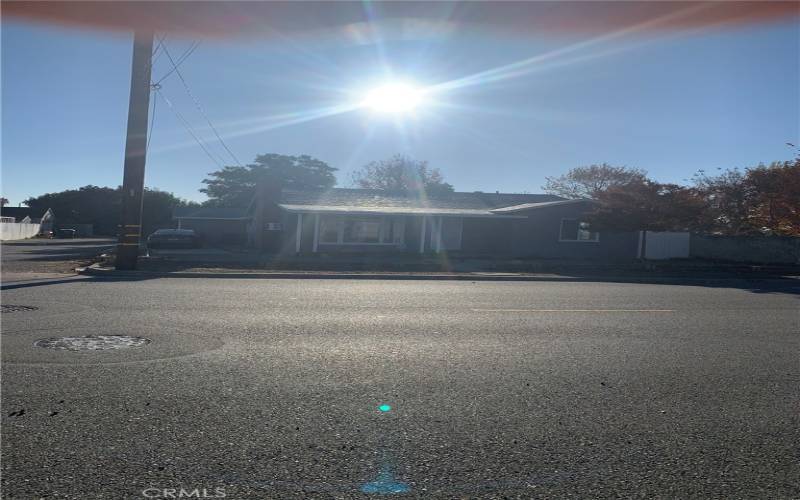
[200,154,337,207]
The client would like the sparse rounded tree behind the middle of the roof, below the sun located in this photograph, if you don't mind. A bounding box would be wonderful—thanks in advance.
[353,154,453,195]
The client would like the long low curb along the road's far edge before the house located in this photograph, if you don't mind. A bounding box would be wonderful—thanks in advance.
[75,265,800,286]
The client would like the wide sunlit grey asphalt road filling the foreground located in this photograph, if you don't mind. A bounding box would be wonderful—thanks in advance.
[2,278,800,499]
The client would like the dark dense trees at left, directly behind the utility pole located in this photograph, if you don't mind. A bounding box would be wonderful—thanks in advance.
[24,185,193,236]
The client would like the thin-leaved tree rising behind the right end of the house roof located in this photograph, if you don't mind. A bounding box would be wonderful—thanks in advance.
[542,163,647,199]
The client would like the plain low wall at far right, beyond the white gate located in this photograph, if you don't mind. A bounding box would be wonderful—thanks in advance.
[690,234,800,264]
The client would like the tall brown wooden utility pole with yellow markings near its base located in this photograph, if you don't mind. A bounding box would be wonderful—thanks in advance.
[116,30,153,269]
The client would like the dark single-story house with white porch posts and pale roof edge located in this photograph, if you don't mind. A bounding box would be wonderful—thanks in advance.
[222,185,640,260]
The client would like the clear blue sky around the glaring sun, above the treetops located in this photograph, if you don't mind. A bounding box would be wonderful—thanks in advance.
[2,12,800,206]
